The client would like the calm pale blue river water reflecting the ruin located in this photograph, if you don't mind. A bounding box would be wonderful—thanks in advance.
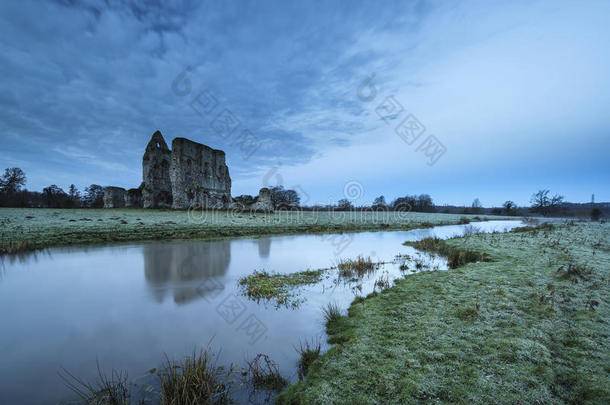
[0,221,521,404]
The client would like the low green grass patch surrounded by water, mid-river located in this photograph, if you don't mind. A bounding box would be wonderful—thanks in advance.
[238,269,324,308]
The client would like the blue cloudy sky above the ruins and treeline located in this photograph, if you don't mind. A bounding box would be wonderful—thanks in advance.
[0,0,610,206]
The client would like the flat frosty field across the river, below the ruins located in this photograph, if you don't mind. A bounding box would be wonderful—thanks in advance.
[0,208,508,253]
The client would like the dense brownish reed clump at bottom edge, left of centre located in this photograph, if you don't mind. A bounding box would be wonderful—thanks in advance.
[158,350,233,405]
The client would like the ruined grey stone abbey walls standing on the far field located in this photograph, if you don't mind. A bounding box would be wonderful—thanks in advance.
[104,131,273,211]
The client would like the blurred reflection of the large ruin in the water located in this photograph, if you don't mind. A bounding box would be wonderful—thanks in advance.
[142,241,231,304]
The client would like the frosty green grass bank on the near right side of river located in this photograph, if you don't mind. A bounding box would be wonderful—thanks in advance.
[277,223,610,404]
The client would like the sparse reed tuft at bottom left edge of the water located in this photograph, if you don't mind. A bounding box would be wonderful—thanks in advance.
[59,362,131,405]
